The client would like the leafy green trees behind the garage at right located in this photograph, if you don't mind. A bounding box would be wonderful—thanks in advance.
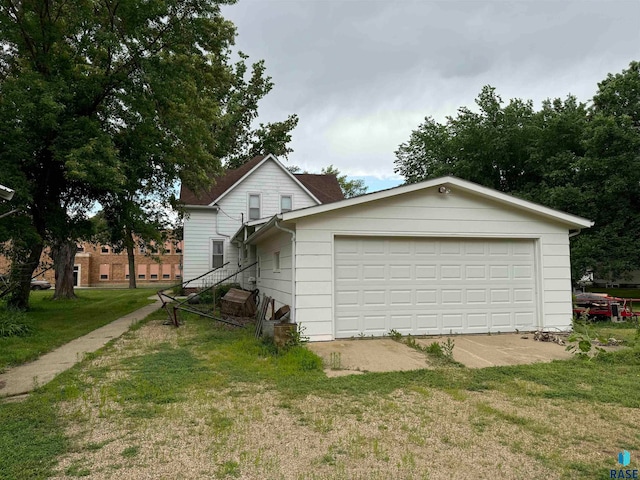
[395,62,640,278]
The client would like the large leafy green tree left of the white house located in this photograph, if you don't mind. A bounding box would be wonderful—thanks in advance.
[0,0,295,308]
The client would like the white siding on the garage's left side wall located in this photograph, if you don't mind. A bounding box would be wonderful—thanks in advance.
[256,232,292,309]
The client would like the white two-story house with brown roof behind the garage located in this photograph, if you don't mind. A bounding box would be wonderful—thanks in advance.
[180,155,344,288]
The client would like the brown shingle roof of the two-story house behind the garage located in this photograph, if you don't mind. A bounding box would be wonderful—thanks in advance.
[180,155,344,205]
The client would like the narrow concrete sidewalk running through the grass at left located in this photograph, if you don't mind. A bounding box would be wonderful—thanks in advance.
[0,297,162,398]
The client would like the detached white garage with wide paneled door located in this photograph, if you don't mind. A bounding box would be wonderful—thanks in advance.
[245,177,592,341]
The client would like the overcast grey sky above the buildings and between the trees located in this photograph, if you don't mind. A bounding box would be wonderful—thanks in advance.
[223,0,640,189]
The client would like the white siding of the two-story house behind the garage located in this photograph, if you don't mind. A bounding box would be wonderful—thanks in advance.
[183,159,317,288]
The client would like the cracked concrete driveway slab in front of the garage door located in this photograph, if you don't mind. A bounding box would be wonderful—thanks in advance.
[308,333,572,376]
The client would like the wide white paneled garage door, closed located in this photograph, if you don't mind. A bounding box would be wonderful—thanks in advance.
[335,237,537,338]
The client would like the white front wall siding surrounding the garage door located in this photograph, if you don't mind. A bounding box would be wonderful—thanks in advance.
[295,187,572,341]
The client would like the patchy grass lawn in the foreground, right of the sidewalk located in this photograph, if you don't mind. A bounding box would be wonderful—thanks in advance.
[0,310,640,479]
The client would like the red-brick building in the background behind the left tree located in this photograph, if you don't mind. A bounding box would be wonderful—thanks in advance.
[0,241,182,287]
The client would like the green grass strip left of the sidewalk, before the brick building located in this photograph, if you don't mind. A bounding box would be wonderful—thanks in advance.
[0,289,155,372]
